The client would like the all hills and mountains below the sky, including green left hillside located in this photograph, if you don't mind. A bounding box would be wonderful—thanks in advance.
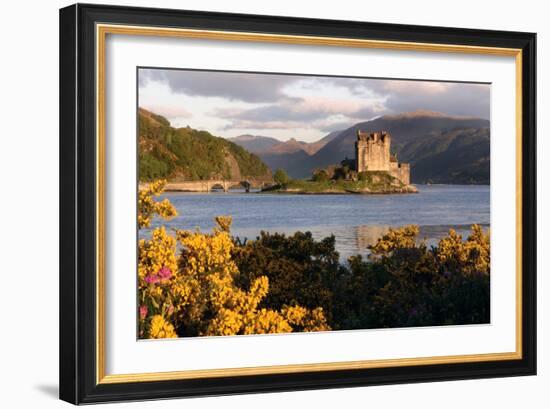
[139,109,490,184]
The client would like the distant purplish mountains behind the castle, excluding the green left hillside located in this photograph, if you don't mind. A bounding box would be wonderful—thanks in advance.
[232,111,490,184]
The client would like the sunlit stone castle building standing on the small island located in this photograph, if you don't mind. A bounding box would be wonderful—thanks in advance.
[355,130,411,185]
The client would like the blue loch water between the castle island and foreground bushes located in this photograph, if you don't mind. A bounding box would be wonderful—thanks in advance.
[146,185,490,261]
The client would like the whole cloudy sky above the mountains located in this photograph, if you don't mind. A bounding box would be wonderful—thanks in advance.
[138,68,490,142]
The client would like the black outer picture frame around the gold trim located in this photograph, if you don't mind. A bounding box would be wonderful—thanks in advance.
[59,4,536,404]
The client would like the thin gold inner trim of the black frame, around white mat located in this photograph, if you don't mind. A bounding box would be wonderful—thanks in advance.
[96,24,523,384]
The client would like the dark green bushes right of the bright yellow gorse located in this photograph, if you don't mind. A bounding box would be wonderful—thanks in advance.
[234,225,490,329]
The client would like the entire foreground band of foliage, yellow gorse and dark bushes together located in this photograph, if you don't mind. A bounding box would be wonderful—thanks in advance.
[138,181,490,338]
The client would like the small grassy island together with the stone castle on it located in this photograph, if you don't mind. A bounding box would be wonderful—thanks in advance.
[262,130,418,194]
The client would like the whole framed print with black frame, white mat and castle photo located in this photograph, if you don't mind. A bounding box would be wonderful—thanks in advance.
[60,5,536,404]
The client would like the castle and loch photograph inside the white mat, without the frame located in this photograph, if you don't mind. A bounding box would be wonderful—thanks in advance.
[136,67,492,339]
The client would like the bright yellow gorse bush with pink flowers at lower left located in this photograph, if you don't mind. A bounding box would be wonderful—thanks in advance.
[138,181,330,338]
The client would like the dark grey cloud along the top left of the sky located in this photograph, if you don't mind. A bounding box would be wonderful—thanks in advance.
[139,69,298,102]
